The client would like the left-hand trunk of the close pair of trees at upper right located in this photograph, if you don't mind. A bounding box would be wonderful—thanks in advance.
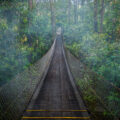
[94,0,98,32]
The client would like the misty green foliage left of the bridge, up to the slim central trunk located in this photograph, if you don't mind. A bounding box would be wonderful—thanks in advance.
[0,0,52,85]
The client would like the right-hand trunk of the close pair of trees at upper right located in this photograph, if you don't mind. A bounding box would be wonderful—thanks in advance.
[100,0,105,33]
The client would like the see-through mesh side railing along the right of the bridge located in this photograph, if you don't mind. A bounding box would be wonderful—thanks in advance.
[66,49,120,120]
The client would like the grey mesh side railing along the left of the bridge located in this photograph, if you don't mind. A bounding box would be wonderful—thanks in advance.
[0,41,56,120]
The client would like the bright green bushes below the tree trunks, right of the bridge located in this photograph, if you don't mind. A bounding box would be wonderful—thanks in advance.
[68,33,120,87]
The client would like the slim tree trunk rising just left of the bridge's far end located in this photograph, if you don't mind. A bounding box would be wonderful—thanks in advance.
[50,0,55,39]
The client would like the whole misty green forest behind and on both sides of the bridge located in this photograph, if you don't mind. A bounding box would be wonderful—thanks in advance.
[0,0,120,118]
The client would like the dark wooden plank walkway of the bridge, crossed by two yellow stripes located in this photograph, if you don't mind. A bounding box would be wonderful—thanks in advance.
[22,35,90,120]
